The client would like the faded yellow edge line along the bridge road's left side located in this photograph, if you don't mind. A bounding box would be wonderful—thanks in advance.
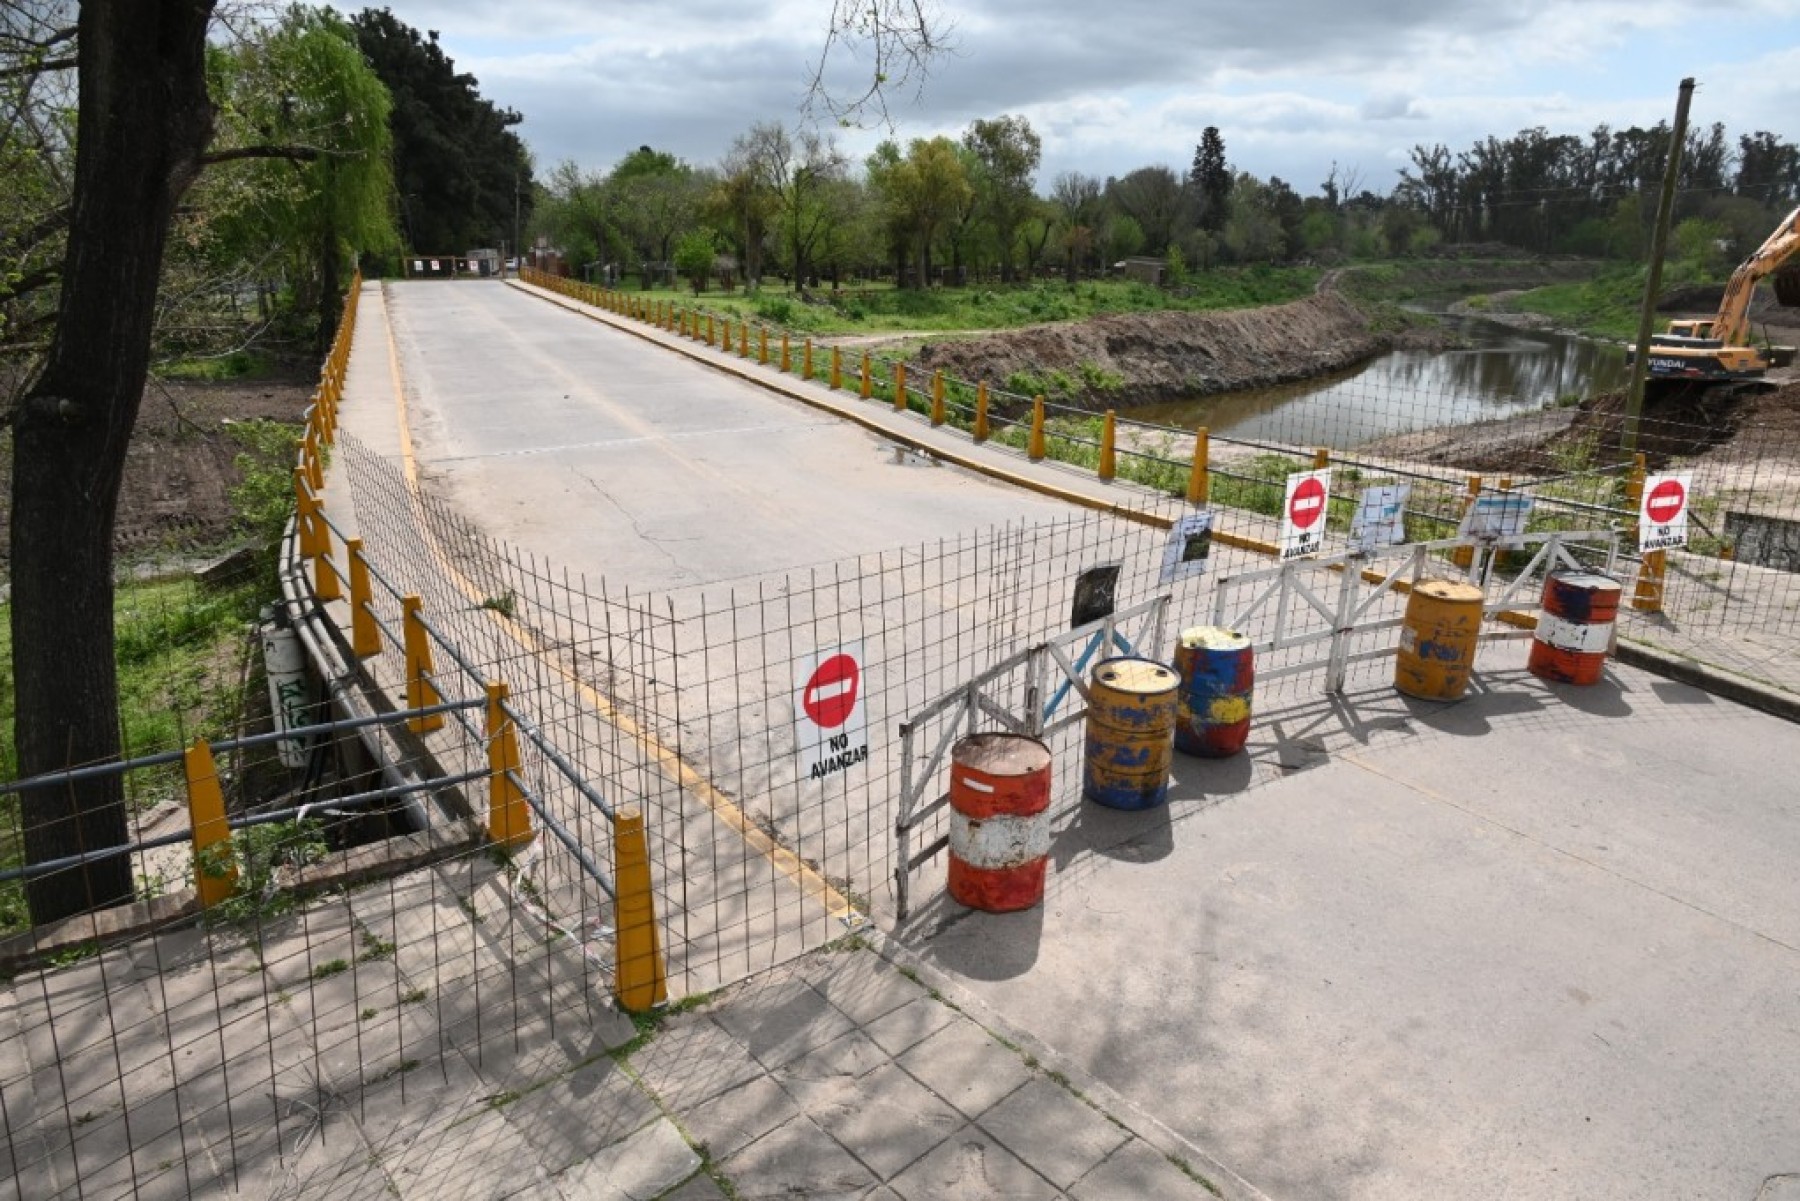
[370,282,860,918]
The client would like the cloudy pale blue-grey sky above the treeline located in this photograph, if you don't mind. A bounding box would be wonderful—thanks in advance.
[372,0,1800,194]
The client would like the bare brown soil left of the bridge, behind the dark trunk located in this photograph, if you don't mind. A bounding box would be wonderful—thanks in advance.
[0,380,313,565]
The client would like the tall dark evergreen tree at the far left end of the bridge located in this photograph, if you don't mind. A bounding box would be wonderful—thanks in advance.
[351,9,531,254]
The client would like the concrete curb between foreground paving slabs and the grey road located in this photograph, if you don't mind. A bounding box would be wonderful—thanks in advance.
[859,927,1271,1201]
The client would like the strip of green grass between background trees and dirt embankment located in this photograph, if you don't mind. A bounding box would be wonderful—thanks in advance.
[650,266,1319,335]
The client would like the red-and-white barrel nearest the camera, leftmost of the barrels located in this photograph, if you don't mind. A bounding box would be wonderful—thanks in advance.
[949,733,1049,913]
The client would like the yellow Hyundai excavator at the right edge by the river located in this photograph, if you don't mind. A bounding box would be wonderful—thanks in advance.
[1645,209,1800,387]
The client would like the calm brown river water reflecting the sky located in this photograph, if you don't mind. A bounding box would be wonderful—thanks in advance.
[1129,313,1625,450]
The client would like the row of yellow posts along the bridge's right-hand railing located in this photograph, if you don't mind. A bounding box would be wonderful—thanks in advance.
[520,268,1667,612]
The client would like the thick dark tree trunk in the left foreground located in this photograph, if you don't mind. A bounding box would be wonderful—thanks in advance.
[13,0,214,922]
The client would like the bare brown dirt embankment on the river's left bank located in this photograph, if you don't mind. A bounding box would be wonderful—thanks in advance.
[914,292,1393,411]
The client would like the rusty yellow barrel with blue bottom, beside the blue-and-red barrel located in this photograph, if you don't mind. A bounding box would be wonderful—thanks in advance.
[1082,657,1181,808]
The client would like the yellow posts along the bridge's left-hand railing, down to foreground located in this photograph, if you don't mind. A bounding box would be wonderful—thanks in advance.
[184,272,668,1012]
